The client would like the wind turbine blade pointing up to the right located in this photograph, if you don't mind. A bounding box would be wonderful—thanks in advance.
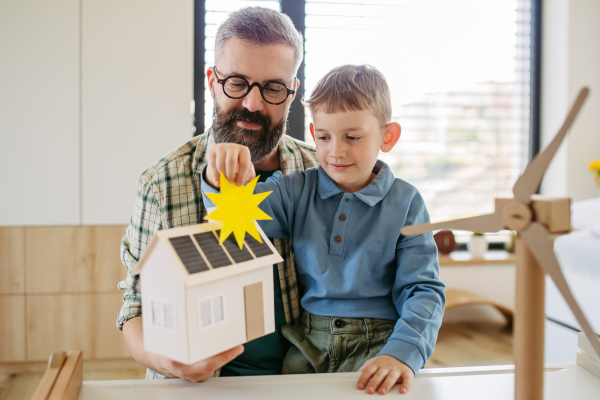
[513,87,590,200]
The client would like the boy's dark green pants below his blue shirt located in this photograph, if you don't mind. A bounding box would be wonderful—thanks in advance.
[281,311,396,374]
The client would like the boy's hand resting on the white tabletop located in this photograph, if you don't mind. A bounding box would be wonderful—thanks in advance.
[356,355,415,394]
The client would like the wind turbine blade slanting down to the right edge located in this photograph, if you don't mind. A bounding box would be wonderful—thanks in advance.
[519,222,600,357]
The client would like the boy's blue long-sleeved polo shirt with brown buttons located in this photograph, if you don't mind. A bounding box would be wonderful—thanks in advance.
[202,160,446,373]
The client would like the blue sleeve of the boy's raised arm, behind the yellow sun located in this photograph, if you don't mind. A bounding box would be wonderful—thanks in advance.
[201,167,306,239]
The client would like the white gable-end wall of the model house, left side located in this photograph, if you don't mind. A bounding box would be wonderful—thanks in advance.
[140,242,189,364]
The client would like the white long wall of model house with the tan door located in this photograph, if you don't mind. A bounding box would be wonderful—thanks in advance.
[187,265,275,362]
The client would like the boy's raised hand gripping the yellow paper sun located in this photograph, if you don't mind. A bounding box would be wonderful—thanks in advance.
[206,143,256,188]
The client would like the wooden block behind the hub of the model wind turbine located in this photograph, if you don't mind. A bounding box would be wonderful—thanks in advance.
[494,194,571,233]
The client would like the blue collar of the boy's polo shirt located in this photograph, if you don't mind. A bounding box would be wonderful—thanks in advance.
[317,160,394,206]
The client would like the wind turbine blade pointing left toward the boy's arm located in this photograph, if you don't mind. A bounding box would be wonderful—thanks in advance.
[402,212,504,236]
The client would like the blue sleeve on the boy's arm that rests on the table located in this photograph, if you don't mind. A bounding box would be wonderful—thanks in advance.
[378,192,446,375]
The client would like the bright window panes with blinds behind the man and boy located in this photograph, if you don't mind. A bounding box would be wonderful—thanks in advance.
[197,0,539,230]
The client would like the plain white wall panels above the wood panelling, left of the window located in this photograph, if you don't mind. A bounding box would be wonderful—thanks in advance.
[0,0,194,226]
